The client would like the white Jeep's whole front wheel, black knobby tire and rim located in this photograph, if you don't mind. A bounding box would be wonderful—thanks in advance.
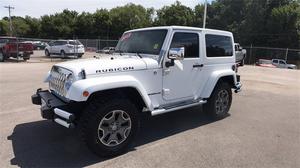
[80,99,139,157]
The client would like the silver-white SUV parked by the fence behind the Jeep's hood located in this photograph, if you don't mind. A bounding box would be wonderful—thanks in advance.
[45,40,85,58]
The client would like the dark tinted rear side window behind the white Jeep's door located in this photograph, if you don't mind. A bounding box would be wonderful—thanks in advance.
[205,34,233,57]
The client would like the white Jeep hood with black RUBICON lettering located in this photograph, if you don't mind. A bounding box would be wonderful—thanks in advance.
[57,56,158,75]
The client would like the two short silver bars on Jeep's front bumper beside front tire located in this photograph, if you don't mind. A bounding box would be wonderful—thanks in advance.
[53,108,75,128]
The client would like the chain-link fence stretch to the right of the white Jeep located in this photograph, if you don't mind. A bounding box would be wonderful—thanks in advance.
[244,46,300,67]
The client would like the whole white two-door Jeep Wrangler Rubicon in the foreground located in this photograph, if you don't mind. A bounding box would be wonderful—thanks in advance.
[32,26,241,156]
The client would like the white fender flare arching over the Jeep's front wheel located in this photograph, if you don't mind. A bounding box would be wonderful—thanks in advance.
[66,75,153,110]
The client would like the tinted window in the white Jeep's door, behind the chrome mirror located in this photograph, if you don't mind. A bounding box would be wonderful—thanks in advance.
[170,33,199,58]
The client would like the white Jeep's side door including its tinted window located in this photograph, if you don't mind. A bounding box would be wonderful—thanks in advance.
[163,31,203,101]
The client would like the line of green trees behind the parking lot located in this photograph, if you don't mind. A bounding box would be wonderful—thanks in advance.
[0,0,300,48]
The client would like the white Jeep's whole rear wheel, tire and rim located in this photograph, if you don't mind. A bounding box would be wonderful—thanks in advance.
[203,82,232,119]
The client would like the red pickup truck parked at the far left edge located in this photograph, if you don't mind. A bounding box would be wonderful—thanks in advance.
[0,36,33,62]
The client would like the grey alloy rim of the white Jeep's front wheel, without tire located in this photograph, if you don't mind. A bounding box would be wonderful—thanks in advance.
[98,110,131,147]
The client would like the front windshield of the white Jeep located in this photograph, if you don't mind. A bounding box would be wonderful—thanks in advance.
[115,29,167,55]
